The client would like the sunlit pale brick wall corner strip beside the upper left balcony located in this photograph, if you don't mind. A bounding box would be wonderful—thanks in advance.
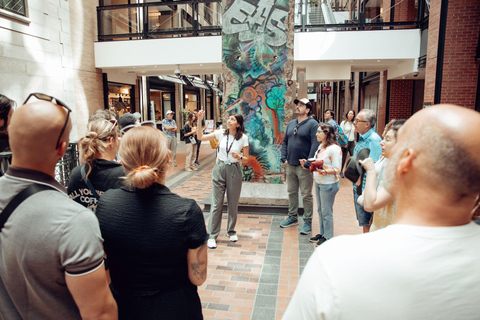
[69,0,104,137]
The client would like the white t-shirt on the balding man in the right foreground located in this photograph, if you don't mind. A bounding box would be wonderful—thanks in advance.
[282,222,480,320]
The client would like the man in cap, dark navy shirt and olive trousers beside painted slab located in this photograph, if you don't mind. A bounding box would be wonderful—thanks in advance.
[280,98,318,235]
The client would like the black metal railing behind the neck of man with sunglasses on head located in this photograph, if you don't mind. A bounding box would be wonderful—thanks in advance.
[0,142,79,187]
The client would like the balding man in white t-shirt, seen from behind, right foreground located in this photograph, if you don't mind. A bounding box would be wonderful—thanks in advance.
[283,105,480,320]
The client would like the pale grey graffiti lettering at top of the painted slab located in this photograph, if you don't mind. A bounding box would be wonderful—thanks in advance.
[223,0,288,47]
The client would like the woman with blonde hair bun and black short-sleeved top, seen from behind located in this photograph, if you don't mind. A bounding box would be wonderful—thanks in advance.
[96,127,208,320]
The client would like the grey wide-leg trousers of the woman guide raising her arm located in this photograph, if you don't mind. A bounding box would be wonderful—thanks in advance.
[208,161,242,239]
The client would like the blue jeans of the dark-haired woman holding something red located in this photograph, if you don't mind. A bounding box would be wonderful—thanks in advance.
[315,182,340,239]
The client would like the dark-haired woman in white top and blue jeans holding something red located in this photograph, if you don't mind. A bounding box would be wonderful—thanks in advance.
[310,122,342,245]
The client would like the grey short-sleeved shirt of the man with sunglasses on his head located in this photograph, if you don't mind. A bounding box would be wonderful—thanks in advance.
[0,167,103,319]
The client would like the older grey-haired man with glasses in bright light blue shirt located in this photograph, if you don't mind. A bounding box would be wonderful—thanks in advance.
[353,109,382,233]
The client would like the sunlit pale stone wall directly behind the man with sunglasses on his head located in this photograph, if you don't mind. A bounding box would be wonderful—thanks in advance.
[0,0,77,139]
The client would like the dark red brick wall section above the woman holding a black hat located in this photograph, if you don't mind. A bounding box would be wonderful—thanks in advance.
[388,80,414,120]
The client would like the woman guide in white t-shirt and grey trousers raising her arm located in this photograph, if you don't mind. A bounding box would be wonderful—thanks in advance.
[197,110,248,249]
